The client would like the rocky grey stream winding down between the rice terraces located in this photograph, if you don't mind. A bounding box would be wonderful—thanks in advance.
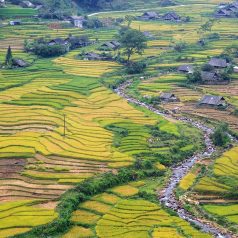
[114,80,235,238]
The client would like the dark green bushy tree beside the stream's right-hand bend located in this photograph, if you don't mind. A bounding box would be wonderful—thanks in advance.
[212,123,230,146]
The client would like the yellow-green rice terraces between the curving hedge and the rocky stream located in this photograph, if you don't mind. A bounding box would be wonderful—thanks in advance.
[63,181,210,238]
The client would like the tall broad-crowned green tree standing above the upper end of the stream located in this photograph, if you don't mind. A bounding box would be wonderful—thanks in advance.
[119,28,147,62]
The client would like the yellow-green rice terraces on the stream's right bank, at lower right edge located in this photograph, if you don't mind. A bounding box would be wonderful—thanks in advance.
[190,147,238,224]
